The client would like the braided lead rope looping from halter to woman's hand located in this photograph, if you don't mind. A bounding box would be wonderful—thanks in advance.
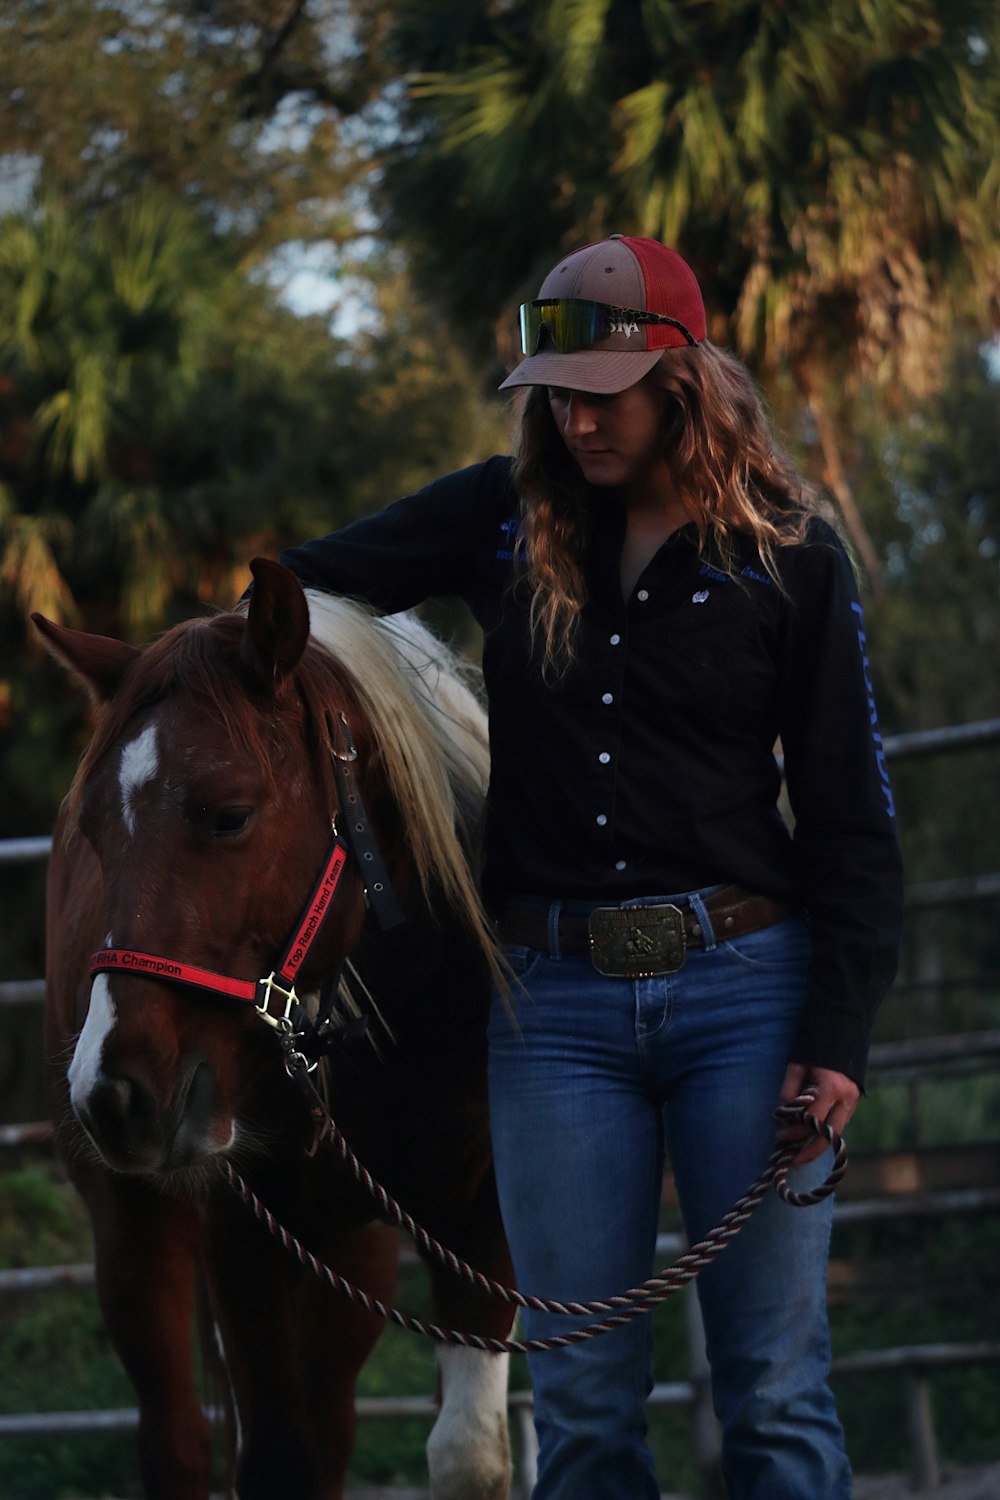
[222,1092,847,1355]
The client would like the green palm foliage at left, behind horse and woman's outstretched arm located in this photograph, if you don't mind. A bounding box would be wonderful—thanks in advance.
[0,195,502,827]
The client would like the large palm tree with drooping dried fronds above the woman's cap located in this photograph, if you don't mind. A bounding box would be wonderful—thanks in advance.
[374,0,1000,588]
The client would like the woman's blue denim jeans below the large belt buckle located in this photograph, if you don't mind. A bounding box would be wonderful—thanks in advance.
[490,893,852,1500]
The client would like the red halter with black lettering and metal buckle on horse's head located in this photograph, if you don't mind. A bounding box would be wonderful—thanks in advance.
[90,714,403,1073]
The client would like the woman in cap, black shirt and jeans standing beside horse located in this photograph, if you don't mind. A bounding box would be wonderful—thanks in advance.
[275,236,901,1500]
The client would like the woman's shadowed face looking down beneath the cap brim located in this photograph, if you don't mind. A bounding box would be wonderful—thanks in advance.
[549,380,669,491]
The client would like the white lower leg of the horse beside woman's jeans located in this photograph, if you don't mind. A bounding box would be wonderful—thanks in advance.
[427,1346,510,1500]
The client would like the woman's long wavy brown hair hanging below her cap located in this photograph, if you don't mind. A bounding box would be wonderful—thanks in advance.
[514,342,817,681]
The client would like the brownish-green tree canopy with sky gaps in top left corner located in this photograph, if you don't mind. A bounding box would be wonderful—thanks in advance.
[0,0,383,258]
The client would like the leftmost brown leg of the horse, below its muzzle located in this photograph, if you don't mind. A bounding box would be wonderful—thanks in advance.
[73,1167,211,1500]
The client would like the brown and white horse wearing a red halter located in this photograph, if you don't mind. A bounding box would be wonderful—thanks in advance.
[37,561,511,1500]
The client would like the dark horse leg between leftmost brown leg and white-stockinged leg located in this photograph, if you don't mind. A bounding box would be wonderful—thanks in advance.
[200,1182,397,1500]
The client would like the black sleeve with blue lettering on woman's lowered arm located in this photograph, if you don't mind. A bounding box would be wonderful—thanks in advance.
[780,524,903,1092]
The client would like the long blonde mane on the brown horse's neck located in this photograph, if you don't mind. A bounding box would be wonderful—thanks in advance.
[299,590,497,992]
